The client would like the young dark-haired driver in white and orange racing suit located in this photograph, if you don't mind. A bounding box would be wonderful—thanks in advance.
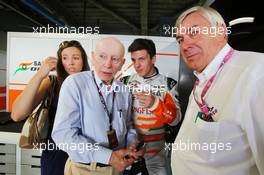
[121,38,181,175]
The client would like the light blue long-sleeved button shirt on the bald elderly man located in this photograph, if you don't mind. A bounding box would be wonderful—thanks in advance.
[52,71,136,164]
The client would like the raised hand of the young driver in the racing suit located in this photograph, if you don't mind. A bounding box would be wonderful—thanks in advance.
[134,92,155,108]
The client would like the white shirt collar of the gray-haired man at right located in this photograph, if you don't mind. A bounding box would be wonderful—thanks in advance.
[194,44,231,82]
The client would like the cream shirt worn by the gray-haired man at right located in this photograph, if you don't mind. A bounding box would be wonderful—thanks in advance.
[171,44,264,175]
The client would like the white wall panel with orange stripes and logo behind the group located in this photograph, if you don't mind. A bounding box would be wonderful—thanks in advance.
[7,32,179,111]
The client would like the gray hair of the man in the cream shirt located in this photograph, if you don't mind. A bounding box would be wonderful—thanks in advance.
[175,6,226,28]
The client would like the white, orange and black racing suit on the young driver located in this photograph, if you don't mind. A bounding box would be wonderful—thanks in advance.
[121,69,181,175]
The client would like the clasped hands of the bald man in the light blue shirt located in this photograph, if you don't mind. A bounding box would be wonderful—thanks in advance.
[110,149,143,172]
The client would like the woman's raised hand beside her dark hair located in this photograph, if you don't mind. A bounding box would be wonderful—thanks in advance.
[38,56,57,79]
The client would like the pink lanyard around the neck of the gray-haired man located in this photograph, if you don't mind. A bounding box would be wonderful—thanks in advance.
[193,48,234,116]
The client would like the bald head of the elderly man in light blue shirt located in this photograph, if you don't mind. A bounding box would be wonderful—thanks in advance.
[92,37,125,84]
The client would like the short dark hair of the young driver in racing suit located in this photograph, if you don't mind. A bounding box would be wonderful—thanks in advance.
[128,38,156,58]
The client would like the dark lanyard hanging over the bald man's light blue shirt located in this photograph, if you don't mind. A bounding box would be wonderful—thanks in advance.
[92,72,115,131]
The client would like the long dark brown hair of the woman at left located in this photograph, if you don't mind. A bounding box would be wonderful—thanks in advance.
[57,40,90,84]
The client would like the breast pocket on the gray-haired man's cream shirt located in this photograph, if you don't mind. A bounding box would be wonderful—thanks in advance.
[188,117,220,161]
